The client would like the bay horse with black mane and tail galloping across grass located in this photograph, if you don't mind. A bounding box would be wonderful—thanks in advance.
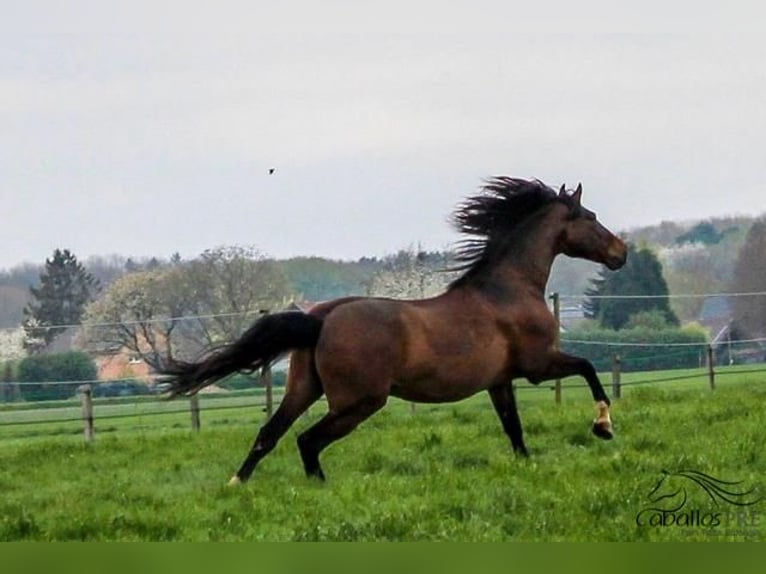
[161,177,627,484]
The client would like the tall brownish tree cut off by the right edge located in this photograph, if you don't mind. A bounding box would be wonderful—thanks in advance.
[731,218,766,336]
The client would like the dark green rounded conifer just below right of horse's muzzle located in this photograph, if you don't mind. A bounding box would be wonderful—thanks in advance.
[584,244,679,329]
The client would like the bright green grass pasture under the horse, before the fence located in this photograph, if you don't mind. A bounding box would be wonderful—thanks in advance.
[0,373,766,541]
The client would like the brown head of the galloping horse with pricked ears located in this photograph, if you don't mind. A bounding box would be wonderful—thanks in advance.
[559,185,628,270]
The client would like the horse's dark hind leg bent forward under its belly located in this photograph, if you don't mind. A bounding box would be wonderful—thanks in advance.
[298,397,386,480]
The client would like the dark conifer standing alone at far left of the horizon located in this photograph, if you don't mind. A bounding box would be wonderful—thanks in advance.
[22,249,100,352]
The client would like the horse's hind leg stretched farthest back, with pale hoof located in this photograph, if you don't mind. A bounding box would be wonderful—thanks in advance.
[229,351,323,485]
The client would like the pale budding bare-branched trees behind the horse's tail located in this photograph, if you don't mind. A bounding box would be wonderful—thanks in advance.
[79,247,290,369]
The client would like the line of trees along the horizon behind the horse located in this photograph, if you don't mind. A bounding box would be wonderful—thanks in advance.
[4,212,766,382]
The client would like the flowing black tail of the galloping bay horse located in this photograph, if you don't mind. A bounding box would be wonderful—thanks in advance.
[160,311,322,397]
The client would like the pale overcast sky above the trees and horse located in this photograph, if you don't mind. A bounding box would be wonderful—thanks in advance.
[0,0,766,269]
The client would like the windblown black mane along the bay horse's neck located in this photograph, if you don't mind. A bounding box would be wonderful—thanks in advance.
[451,177,569,287]
